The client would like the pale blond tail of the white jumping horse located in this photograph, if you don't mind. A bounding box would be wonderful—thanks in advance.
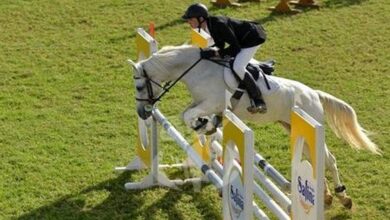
[316,90,382,155]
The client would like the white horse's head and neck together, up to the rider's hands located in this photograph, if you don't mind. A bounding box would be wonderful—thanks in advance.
[129,45,200,120]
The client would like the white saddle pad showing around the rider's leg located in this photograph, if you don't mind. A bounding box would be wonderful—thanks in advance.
[224,59,279,95]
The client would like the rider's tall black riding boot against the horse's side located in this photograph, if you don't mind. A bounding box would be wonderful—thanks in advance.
[242,73,267,113]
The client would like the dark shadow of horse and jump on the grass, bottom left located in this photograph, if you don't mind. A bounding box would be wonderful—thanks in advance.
[17,172,220,220]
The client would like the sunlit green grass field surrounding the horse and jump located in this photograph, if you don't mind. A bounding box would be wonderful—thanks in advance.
[0,0,390,220]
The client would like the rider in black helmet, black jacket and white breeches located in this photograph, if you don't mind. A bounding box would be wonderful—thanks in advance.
[182,3,267,113]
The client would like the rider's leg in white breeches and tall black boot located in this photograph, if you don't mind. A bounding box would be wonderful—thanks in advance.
[233,46,267,113]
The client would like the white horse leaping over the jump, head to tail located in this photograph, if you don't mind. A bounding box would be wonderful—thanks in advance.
[132,45,381,208]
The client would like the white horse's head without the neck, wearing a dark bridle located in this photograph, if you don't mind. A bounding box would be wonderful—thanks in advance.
[129,60,161,120]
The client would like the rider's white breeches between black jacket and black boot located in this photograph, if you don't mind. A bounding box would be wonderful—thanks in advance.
[233,45,260,79]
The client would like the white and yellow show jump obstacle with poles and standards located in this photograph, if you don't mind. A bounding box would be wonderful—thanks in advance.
[116,29,324,219]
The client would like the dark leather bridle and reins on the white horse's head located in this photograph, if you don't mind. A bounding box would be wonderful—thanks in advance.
[133,58,202,105]
